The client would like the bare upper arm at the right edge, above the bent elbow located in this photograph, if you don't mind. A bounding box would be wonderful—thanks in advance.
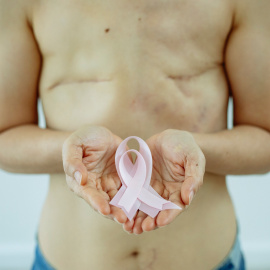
[225,0,270,130]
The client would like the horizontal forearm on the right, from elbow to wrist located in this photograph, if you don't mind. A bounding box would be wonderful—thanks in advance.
[192,126,270,175]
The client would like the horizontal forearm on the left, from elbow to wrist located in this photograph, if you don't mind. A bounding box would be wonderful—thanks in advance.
[0,125,71,173]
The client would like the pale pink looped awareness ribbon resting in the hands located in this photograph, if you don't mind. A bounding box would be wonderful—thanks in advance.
[110,136,181,220]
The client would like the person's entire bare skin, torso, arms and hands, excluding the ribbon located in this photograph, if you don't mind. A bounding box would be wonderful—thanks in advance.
[0,0,270,270]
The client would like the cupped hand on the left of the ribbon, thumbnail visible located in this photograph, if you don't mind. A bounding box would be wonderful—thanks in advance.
[62,126,127,223]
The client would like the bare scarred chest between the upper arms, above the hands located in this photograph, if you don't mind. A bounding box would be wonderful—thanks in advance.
[34,0,231,136]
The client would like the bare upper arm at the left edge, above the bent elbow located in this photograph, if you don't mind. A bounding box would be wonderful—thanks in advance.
[0,0,41,132]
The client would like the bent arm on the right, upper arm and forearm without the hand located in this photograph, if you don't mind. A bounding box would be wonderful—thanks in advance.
[193,1,270,175]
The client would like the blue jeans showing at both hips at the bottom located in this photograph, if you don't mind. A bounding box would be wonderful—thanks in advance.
[32,230,246,270]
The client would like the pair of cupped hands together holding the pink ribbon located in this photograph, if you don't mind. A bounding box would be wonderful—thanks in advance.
[63,126,205,230]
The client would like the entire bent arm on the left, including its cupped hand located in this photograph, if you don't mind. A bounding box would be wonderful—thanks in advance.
[0,0,129,223]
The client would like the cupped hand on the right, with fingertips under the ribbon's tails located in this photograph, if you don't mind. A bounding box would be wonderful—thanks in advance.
[123,129,205,234]
